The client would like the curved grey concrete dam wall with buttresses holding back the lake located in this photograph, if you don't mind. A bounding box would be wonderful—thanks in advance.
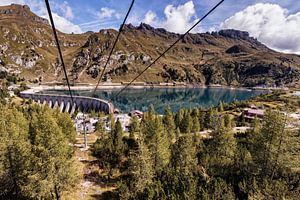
[21,91,113,114]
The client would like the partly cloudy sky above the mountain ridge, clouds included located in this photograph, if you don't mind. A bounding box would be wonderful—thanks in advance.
[0,0,300,54]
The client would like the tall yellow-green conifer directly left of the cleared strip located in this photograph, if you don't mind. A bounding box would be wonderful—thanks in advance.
[27,107,77,199]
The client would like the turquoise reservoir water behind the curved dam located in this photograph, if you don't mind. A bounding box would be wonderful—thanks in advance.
[43,88,262,114]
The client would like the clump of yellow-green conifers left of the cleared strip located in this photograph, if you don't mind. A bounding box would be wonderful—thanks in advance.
[0,106,77,199]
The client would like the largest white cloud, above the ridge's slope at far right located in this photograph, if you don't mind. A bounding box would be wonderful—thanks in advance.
[221,3,300,54]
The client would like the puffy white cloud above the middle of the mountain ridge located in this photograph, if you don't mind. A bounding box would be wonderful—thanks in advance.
[143,1,200,33]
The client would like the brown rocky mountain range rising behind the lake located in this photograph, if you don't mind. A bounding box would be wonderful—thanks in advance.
[0,4,300,86]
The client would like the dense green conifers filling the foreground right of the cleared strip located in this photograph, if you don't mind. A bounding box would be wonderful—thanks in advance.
[94,104,300,200]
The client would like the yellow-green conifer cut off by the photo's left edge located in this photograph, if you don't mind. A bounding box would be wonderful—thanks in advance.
[0,106,31,199]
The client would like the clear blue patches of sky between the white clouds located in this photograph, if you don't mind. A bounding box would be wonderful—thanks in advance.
[52,0,300,31]
